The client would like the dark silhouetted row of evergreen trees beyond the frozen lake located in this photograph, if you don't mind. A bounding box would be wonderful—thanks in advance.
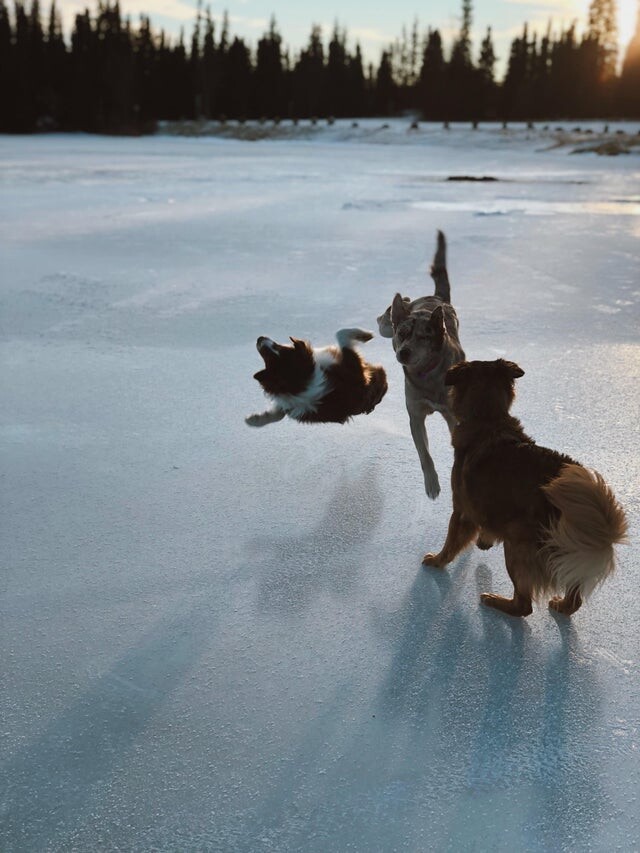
[0,0,640,133]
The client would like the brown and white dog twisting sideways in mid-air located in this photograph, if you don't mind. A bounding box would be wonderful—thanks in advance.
[245,329,387,427]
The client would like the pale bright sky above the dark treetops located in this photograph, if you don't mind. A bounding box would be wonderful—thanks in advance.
[53,0,637,75]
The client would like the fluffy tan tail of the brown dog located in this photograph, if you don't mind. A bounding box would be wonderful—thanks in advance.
[543,465,627,598]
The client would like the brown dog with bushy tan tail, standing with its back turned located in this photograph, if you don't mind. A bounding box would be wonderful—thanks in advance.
[423,359,627,616]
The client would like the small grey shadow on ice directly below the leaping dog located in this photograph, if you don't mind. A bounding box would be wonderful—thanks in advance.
[247,465,384,611]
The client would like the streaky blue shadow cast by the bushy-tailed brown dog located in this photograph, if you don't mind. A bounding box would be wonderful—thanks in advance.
[370,552,606,849]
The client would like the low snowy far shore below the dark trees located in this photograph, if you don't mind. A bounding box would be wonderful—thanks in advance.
[158,118,640,155]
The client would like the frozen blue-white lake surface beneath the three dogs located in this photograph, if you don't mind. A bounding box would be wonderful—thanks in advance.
[0,125,640,853]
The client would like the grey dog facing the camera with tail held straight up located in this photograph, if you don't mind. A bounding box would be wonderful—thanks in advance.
[378,231,465,498]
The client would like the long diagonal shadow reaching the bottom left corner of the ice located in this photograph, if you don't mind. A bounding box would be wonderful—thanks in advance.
[0,601,214,851]
